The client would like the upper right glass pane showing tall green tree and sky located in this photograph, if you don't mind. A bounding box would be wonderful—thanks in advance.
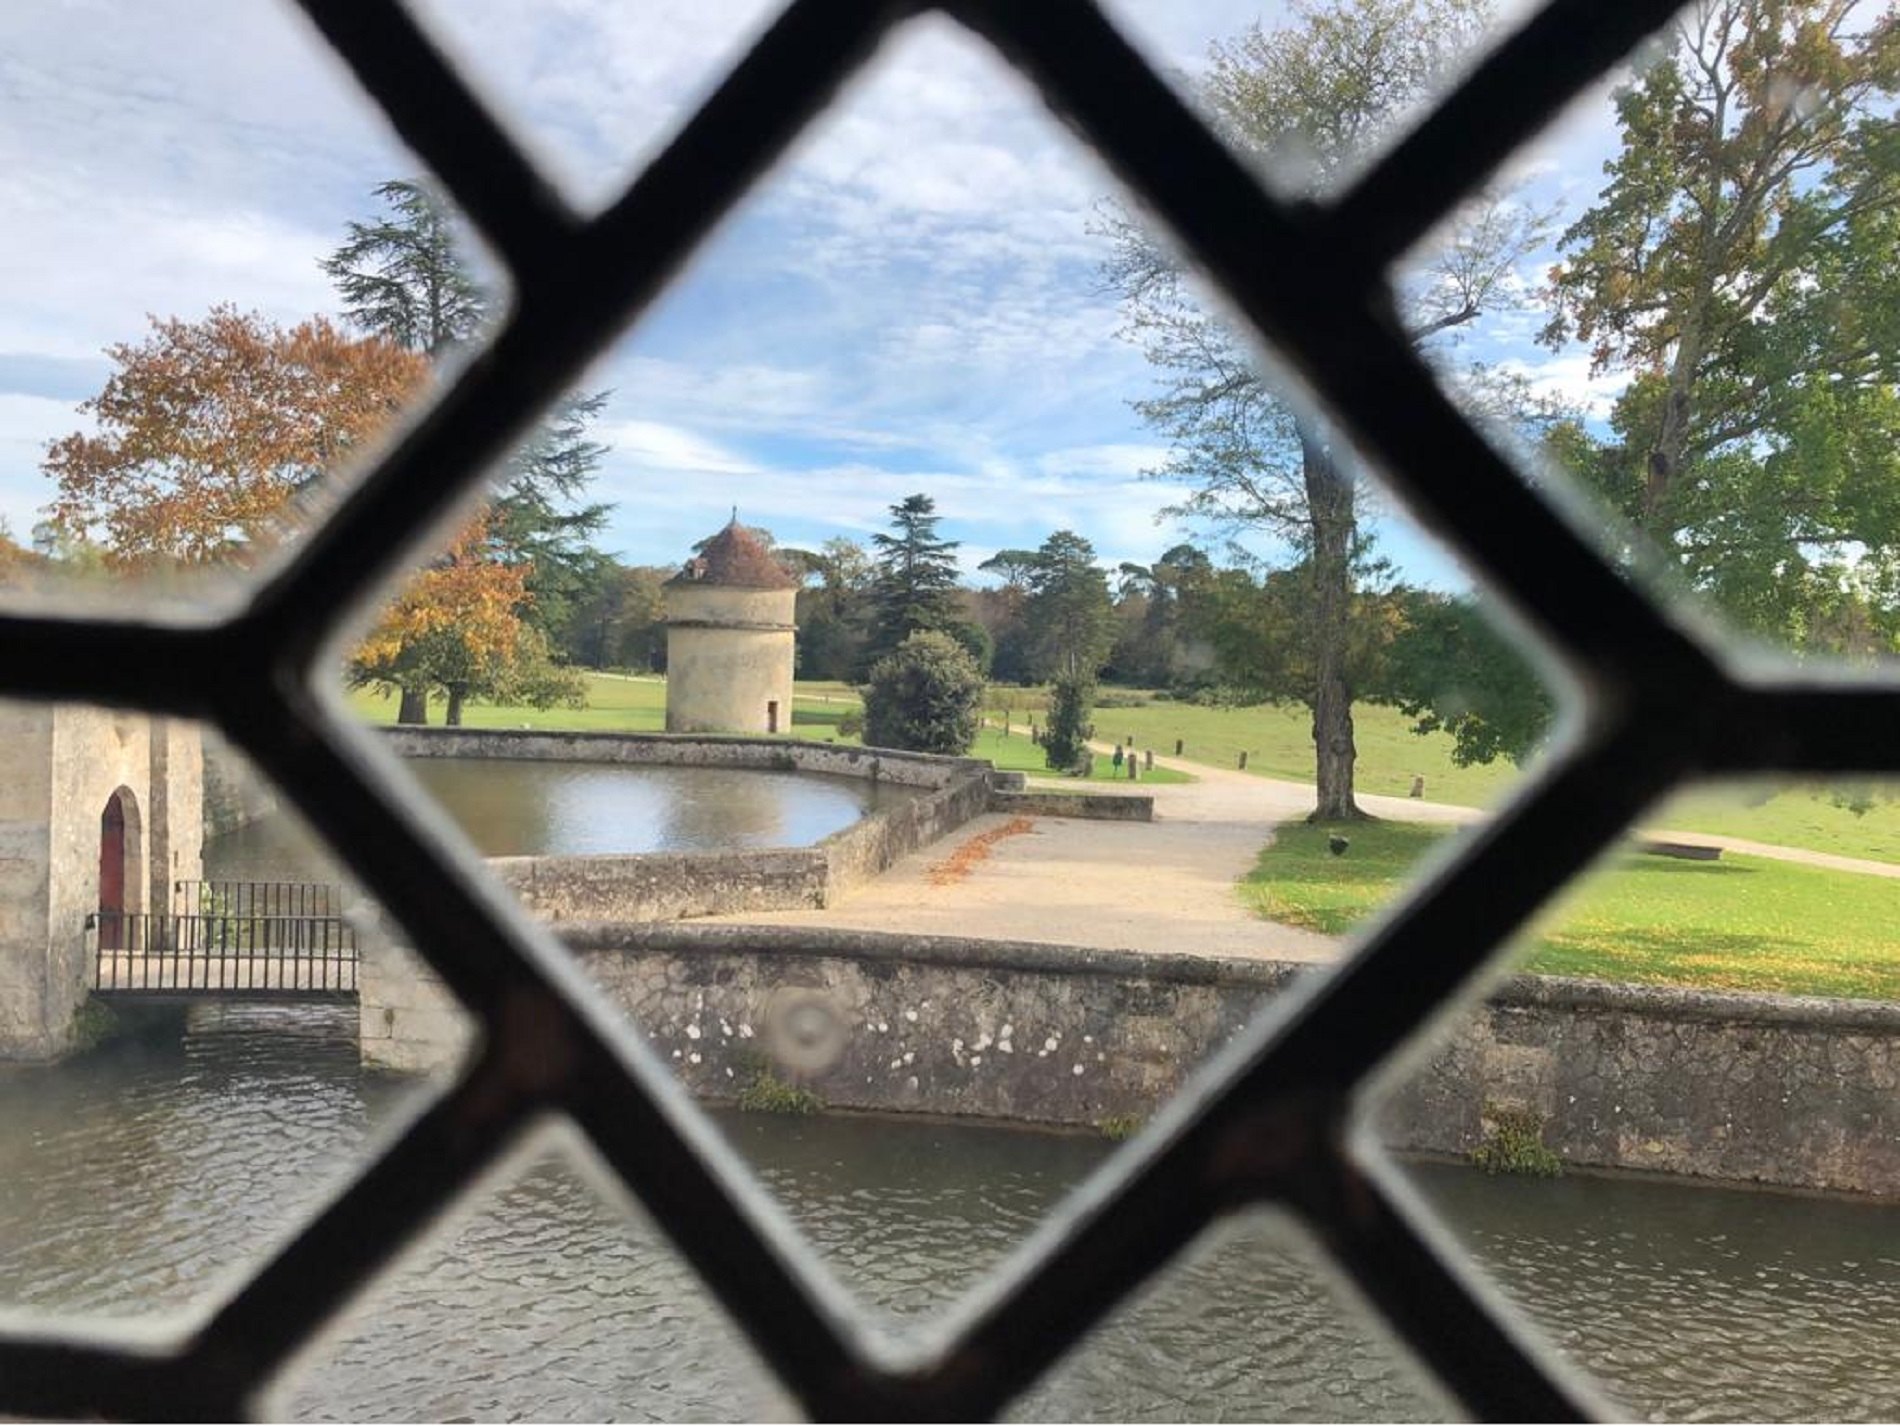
[1408,4,1900,668]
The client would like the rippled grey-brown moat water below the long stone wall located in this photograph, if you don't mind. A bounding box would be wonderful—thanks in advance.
[0,1008,1900,1420]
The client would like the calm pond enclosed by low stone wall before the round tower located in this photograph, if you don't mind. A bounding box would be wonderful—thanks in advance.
[205,758,916,881]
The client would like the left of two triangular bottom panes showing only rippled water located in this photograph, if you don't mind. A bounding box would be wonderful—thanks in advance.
[274,1145,792,1420]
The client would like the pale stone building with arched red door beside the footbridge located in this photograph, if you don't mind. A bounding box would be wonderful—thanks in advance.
[0,703,205,1060]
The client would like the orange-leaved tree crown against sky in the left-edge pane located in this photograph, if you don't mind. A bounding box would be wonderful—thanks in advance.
[44,306,428,568]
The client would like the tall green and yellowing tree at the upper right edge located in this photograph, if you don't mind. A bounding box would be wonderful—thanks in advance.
[1545,0,1900,644]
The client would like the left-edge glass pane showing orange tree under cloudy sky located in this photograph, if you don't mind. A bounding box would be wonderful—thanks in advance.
[0,4,498,611]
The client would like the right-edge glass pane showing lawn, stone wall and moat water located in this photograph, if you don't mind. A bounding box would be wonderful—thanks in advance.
[1381,784,1900,1420]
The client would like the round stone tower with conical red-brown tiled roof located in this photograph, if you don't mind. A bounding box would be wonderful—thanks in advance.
[665,515,798,733]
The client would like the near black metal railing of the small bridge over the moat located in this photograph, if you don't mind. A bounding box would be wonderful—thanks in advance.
[86,911,359,999]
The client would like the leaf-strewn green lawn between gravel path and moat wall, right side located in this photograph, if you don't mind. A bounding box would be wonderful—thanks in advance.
[1241,822,1900,1001]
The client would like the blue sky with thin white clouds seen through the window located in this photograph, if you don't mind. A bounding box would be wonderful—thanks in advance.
[0,0,1634,587]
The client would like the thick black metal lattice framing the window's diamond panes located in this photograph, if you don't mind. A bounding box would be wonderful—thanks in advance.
[0,0,1900,1420]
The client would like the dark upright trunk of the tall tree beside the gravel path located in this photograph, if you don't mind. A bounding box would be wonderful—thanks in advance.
[1300,435,1366,822]
